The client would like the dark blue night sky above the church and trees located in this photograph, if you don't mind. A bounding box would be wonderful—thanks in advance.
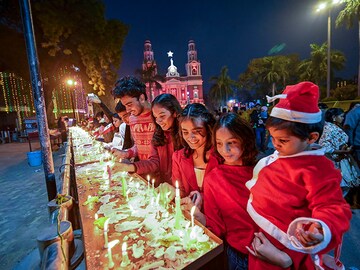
[104,0,359,90]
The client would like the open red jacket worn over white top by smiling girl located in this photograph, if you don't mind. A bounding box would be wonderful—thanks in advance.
[172,149,219,197]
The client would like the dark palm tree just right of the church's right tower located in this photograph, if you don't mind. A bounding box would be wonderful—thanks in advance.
[209,66,236,109]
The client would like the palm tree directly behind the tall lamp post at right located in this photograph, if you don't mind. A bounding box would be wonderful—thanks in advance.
[299,42,346,96]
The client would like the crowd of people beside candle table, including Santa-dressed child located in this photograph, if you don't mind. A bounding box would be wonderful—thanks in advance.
[59,77,360,269]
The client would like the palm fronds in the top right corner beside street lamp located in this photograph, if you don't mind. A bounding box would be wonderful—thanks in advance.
[336,0,360,96]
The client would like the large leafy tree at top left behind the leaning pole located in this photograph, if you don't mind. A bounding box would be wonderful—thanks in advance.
[0,0,128,123]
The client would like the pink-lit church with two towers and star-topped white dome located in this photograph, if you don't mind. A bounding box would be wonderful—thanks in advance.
[142,40,204,106]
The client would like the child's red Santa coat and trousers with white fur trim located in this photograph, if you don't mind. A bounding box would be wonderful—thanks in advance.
[246,149,351,269]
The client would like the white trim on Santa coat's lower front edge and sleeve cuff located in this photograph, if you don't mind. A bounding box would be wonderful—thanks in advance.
[247,198,331,254]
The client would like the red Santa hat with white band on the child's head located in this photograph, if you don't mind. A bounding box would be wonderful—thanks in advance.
[266,82,321,124]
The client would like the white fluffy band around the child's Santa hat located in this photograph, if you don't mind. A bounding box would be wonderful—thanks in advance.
[270,107,321,124]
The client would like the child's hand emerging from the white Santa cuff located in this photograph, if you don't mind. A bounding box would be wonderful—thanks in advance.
[295,222,324,247]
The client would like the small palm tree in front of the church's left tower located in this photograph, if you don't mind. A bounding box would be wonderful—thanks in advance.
[135,61,165,101]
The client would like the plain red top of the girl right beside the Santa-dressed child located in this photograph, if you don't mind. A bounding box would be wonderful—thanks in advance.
[204,164,256,254]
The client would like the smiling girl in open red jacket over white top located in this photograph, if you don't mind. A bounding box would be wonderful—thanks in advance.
[172,103,218,209]
